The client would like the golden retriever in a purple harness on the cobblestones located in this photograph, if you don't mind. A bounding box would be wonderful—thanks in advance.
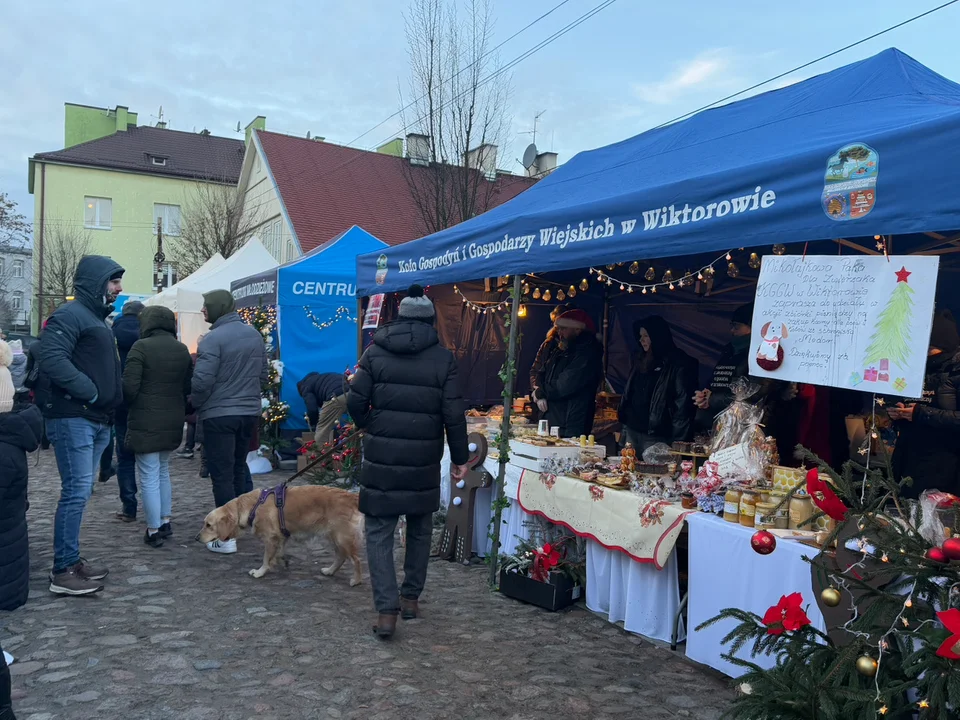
[197,485,363,587]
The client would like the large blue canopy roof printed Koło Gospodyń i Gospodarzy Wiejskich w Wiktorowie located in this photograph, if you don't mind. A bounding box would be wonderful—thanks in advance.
[357,49,960,295]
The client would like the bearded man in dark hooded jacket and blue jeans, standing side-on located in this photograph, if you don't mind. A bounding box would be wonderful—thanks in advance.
[40,255,123,595]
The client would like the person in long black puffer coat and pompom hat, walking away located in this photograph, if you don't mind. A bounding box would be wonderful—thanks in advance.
[347,285,467,639]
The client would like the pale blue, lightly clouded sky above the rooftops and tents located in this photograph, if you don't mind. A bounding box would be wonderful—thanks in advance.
[0,0,960,225]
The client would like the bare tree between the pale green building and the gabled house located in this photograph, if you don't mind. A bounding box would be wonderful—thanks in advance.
[169,183,260,278]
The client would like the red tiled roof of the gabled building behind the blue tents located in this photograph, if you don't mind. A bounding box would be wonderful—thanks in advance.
[257,131,535,252]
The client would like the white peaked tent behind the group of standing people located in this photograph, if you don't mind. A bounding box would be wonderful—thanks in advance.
[144,238,278,352]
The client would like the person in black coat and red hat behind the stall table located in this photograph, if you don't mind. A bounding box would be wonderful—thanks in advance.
[533,310,603,438]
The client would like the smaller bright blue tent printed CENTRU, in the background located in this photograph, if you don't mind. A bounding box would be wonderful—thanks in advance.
[230,226,387,431]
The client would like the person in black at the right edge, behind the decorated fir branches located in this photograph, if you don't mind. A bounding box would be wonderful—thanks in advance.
[887,310,960,499]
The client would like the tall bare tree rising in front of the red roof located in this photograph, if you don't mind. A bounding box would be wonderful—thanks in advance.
[401,0,510,234]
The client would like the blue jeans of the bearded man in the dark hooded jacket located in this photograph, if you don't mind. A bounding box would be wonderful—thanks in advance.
[47,418,110,573]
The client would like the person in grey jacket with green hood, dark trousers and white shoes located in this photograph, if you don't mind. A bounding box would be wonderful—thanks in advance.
[191,290,267,553]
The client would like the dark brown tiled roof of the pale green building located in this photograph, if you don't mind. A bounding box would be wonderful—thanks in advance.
[34,126,244,184]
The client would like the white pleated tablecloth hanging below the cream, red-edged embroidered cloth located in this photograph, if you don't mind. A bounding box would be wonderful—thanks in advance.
[587,540,685,642]
